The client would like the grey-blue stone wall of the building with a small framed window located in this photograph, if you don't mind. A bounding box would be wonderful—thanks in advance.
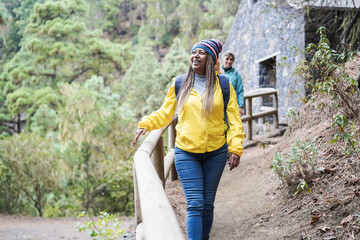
[223,0,305,123]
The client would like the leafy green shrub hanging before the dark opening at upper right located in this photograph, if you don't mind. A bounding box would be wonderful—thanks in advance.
[294,27,360,117]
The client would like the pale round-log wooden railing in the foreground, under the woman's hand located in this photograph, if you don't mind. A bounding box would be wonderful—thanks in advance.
[133,122,185,240]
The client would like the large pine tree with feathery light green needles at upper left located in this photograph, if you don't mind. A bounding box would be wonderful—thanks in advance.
[0,0,132,135]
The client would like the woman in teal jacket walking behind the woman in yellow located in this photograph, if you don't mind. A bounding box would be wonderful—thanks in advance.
[221,51,244,116]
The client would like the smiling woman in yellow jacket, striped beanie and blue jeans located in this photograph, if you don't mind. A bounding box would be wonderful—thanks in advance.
[133,39,244,240]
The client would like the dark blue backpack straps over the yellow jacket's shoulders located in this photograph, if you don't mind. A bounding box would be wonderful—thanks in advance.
[175,74,230,128]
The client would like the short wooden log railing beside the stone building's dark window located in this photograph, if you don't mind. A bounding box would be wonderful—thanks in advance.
[241,88,279,140]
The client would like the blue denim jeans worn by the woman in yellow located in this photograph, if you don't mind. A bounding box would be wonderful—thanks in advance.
[175,144,228,240]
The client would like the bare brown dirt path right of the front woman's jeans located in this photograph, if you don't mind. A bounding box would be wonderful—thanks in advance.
[211,138,289,240]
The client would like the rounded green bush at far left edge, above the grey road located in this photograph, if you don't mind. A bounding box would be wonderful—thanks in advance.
[0,133,60,216]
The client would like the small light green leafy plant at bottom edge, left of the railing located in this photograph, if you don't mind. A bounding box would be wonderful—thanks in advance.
[77,212,125,240]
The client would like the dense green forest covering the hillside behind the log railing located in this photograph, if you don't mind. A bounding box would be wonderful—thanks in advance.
[0,0,239,217]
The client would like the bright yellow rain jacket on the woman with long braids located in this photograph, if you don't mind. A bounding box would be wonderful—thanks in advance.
[138,76,245,156]
